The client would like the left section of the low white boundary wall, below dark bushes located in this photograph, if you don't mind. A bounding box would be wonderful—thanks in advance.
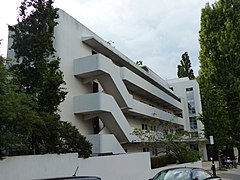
[0,154,78,180]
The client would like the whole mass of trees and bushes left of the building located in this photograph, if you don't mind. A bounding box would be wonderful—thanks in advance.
[0,0,92,157]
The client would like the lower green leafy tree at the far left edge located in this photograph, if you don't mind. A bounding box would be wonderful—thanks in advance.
[0,49,43,158]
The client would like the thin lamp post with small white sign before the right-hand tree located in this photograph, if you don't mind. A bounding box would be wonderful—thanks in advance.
[206,86,219,176]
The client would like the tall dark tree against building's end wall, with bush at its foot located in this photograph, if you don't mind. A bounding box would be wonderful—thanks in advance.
[5,0,91,157]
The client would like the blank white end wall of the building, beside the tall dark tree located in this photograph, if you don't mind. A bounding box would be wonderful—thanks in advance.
[54,10,93,135]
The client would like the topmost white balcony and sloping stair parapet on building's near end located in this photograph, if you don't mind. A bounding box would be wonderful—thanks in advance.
[74,54,132,109]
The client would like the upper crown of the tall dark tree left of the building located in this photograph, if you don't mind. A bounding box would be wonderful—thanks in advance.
[9,0,67,114]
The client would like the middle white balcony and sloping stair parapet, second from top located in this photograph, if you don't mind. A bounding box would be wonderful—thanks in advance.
[74,93,133,143]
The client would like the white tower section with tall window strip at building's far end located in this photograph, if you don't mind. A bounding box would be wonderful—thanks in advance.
[167,78,207,160]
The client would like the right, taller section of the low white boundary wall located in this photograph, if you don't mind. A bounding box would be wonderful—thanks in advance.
[78,153,151,180]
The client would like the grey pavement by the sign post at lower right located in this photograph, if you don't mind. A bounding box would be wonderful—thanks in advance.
[202,161,240,180]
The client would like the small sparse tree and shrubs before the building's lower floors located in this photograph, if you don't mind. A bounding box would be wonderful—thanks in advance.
[133,121,200,163]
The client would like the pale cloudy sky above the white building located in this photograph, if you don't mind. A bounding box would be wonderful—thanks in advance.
[0,0,215,80]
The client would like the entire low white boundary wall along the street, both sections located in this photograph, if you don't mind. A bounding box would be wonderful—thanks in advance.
[0,153,151,180]
